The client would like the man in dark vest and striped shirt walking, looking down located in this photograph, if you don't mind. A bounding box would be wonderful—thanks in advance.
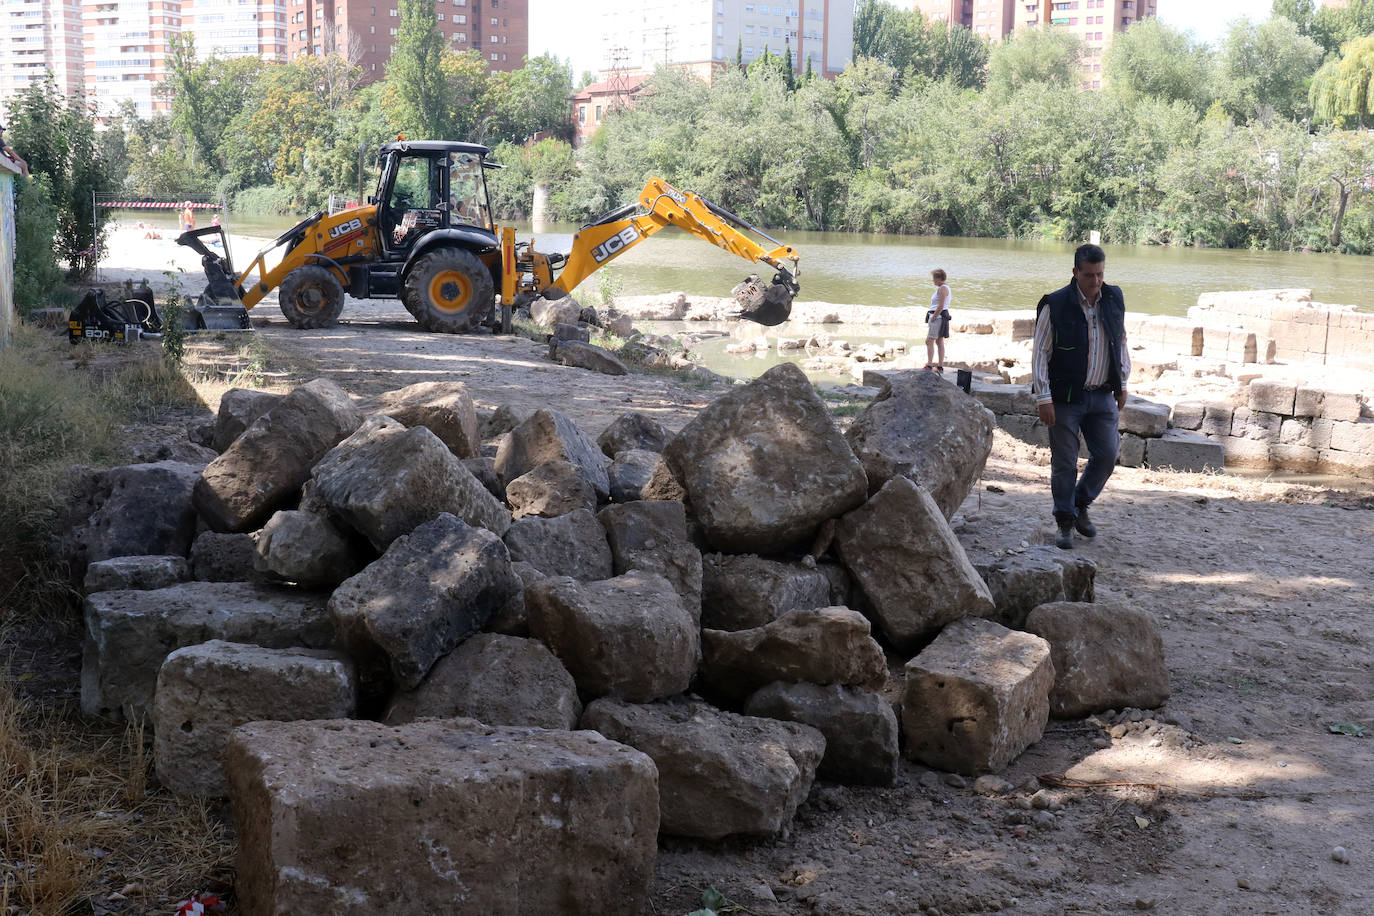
[1031,244,1131,551]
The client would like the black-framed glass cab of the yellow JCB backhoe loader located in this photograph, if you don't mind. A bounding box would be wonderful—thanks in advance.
[375,140,496,258]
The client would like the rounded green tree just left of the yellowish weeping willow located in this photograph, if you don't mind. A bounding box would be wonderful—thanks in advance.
[1217,18,1322,122]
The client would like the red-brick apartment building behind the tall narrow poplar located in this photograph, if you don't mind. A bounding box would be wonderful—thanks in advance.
[284,0,529,82]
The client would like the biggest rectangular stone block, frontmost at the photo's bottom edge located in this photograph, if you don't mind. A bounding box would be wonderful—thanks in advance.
[225,720,658,916]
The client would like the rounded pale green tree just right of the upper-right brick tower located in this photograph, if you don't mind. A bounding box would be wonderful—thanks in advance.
[1103,17,1214,110]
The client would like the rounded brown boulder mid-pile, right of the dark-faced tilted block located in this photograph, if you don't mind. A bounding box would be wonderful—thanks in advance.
[525,570,701,703]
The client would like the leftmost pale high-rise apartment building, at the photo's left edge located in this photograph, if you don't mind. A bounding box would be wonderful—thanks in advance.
[0,0,85,99]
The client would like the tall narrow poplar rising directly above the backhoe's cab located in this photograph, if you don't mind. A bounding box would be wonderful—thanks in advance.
[386,0,456,139]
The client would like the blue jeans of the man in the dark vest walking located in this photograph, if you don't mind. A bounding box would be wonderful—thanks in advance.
[1048,389,1121,522]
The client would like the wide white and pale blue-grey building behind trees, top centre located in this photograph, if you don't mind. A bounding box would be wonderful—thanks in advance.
[599,0,855,80]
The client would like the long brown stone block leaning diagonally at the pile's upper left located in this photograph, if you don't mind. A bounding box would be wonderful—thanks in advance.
[194,379,363,531]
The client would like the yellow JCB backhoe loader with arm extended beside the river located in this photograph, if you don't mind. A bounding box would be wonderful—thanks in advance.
[177,140,800,334]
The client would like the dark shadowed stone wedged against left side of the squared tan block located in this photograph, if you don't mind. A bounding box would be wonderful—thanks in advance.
[745,681,899,786]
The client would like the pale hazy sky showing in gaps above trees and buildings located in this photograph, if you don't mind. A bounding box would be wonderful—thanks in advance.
[529,0,1272,80]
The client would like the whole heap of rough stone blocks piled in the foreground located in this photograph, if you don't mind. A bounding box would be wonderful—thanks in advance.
[73,364,1168,913]
